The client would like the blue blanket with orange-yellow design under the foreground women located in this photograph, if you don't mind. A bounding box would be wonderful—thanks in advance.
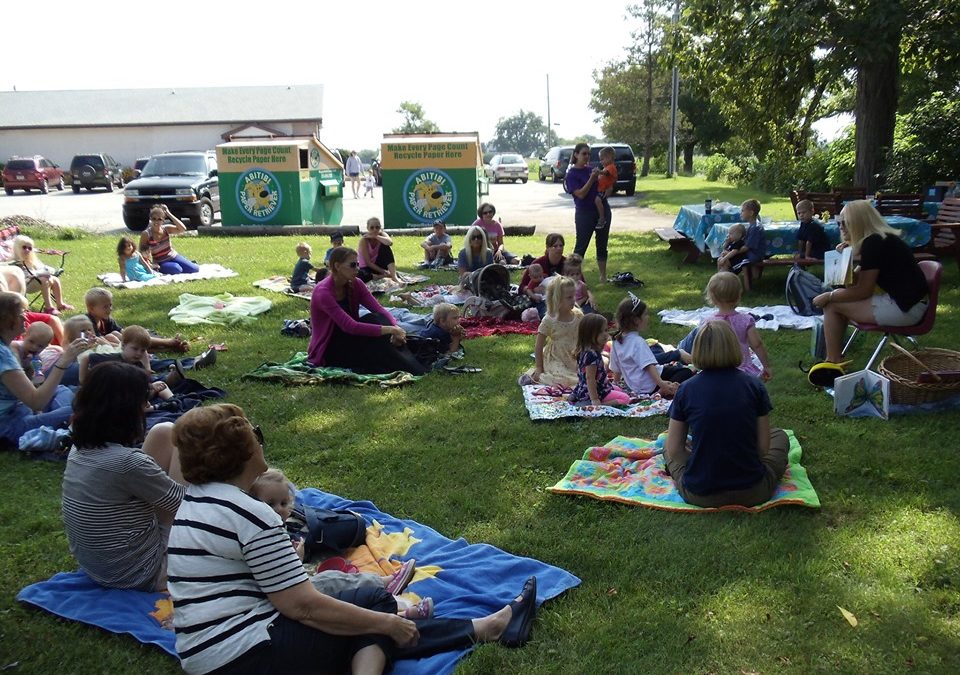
[17,489,580,675]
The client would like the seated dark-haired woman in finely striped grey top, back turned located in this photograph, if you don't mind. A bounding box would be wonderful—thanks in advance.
[62,361,184,591]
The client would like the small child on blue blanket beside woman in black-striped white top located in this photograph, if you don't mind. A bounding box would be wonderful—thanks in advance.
[250,469,433,619]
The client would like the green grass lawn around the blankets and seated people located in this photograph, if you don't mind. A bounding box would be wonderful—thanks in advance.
[0,228,960,675]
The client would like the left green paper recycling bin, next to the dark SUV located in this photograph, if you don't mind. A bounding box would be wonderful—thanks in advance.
[217,136,343,226]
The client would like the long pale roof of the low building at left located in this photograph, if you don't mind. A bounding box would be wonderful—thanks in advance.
[0,84,323,129]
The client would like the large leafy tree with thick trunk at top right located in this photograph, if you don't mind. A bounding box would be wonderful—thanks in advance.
[677,0,960,190]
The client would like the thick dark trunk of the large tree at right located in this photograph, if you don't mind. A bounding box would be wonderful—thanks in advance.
[854,37,903,193]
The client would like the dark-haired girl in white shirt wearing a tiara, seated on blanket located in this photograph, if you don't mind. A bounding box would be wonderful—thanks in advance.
[610,293,693,398]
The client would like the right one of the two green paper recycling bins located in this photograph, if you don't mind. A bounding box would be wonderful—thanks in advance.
[380,133,485,228]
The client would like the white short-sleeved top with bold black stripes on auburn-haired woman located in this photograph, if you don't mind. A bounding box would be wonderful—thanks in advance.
[167,483,308,673]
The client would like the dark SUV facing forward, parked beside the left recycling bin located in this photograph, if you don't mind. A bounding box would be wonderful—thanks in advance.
[123,150,220,232]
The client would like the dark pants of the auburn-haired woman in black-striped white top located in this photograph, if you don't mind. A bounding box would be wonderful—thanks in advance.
[213,587,476,675]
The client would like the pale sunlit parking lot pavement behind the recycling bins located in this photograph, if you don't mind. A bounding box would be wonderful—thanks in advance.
[0,180,673,234]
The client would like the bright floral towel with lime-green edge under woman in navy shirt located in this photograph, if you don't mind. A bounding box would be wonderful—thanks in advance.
[548,429,820,513]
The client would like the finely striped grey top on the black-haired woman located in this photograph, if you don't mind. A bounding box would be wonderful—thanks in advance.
[61,443,184,590]
